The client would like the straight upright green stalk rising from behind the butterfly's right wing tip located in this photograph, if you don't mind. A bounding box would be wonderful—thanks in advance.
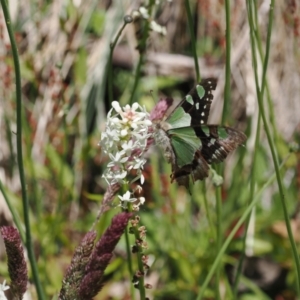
[222,0,231,124]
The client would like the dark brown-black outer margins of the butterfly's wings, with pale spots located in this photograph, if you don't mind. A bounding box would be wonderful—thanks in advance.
[166,78,246,189]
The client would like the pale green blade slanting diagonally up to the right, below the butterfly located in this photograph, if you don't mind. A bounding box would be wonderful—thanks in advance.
[196,158,290,300]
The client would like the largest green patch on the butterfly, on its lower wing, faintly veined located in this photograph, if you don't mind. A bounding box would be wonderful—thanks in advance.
[168,127,202,168]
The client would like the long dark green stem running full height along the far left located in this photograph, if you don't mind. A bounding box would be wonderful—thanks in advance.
[1,0,45,300]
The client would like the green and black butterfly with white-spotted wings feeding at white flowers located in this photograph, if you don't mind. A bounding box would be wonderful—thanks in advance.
[151,78,246,190]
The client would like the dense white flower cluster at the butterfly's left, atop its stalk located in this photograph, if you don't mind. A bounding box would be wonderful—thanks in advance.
[100,101,152,206]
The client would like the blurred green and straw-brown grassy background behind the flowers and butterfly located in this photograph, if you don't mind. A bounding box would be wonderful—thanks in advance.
[0,0,300,299]
